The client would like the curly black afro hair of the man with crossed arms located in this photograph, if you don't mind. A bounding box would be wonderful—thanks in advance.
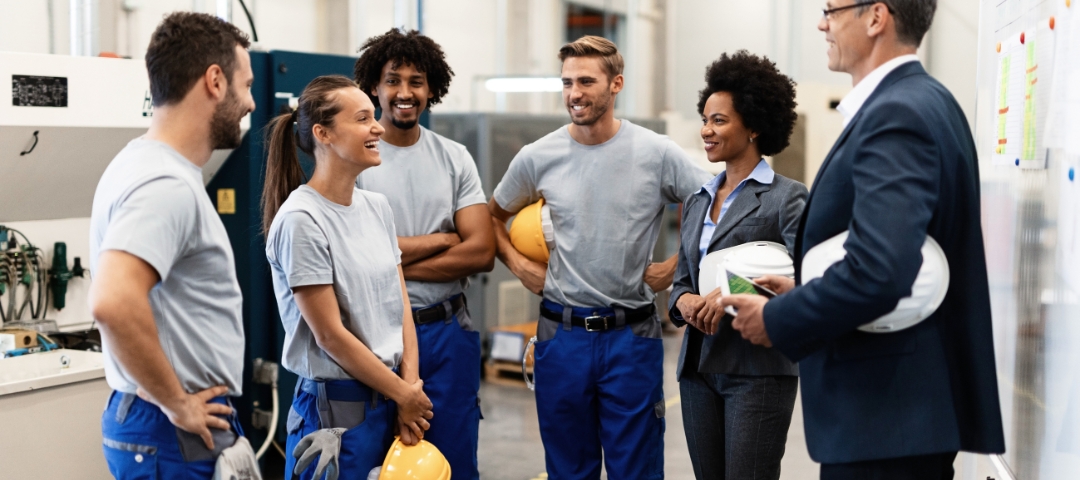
[353,28,454,108]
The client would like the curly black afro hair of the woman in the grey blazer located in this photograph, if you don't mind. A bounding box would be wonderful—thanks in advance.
[698,50,798,156]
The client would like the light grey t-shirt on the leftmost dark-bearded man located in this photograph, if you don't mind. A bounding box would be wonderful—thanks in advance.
[90,138,244,396]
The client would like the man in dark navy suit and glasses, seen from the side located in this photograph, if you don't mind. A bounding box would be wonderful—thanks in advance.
[721,0,1004,480]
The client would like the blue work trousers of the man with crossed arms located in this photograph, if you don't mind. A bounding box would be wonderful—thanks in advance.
[413,294,481,480]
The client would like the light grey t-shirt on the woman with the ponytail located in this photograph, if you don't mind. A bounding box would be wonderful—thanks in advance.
[267,185,405,379]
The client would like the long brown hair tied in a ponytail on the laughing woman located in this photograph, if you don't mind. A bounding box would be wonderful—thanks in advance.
[262,75,357,236]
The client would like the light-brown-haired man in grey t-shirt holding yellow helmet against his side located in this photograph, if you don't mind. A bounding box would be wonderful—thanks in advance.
[488,36,711,480]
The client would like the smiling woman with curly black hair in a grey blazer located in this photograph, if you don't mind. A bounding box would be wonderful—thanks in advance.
[669,51,807,479]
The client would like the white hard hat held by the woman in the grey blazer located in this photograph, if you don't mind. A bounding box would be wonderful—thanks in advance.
[698,242,795,295]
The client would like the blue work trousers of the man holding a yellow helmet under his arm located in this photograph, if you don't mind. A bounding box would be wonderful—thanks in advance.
[534,299,665,480]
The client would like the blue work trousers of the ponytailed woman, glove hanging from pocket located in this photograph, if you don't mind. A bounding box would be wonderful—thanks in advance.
[285,377,397,480]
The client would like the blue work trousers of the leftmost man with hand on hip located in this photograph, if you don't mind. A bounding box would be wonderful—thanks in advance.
[102,391,244,480]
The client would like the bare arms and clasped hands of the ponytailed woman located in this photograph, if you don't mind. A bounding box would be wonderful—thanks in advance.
[293,285,432,437]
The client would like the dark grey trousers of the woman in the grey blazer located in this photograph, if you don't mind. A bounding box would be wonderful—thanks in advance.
[679,373,799,480]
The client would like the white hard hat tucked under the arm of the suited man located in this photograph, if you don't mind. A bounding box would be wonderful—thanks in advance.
[802,231,948,333]
